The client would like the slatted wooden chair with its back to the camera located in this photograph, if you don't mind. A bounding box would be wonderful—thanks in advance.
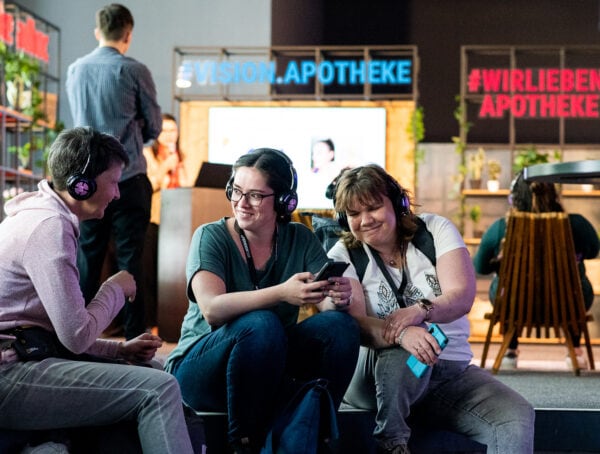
[481,211,595,375]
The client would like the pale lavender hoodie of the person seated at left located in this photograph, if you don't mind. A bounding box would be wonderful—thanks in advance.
[0,181,125,357]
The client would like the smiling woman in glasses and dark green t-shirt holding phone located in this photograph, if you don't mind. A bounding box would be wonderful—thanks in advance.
[165,148,359,452]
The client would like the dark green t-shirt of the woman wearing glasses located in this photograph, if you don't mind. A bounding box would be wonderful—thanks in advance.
[165,218,327,371]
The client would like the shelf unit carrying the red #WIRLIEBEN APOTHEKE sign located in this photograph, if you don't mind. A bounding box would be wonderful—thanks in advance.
[458,45,600,246]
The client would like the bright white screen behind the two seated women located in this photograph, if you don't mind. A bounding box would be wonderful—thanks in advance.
[208,107,386,209]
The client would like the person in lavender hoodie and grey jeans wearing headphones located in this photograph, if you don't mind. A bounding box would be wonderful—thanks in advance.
[0,128,192,454]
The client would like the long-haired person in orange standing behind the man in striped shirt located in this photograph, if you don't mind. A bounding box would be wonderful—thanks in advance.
[142,113,188,326]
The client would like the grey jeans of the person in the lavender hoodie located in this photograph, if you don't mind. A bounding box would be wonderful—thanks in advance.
[0,358,193,454]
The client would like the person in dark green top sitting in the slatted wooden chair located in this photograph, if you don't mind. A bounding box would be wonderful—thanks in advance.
[473,172,600,369]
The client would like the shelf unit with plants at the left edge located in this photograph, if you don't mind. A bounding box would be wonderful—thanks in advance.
[0,2,60,221]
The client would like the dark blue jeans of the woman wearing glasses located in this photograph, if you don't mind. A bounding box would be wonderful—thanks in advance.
[173,310,360,444]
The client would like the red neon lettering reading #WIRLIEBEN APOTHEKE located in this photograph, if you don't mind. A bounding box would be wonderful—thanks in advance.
[467,68,600,119]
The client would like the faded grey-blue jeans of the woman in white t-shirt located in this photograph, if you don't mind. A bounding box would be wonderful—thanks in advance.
[344,347,535,454]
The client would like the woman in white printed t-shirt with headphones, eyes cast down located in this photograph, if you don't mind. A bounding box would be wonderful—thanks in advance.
[329,165,534,454]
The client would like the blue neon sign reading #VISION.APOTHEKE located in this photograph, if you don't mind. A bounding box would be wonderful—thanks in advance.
[177,59,412,88]
